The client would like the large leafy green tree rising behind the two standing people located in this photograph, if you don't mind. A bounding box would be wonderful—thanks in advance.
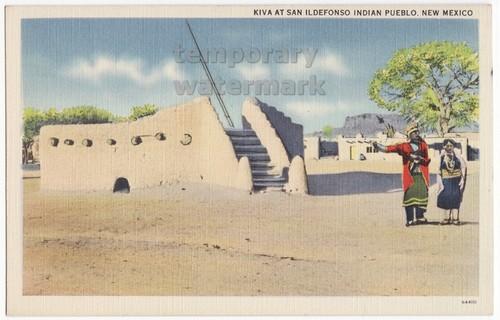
[368,41,479,136]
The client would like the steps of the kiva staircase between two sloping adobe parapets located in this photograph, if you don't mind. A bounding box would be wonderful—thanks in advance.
[226,129,287,191]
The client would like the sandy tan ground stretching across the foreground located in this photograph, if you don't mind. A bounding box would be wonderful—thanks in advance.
[23,164,479,296]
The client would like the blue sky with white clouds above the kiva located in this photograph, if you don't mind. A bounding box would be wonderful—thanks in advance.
[22,19,478,132]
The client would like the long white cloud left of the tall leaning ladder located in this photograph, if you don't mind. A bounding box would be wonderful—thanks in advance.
[66,56,184,86]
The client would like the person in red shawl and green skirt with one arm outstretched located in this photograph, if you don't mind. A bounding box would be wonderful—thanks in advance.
[373,124,431,227]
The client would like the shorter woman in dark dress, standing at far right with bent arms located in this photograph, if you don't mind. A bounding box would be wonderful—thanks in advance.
[437,139,467,225]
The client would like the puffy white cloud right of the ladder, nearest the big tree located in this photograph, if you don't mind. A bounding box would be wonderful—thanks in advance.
[279,51,349,79]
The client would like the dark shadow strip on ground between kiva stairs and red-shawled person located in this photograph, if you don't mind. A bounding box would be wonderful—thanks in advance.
[307,172,436,196]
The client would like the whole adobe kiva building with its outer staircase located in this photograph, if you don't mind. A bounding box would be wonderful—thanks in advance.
[40,97,307,193]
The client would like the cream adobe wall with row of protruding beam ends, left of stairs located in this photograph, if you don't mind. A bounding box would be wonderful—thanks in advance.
[40,97,251,190]
